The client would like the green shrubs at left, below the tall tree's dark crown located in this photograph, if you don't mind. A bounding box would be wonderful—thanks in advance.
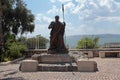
[0,34,27,61]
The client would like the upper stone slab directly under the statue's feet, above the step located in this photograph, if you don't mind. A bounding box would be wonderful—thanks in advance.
[32,54,72,64]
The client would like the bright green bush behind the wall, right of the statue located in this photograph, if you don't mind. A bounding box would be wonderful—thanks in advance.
[77,36,99,49]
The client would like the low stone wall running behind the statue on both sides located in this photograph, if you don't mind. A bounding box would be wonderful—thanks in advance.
[26,49,120,58]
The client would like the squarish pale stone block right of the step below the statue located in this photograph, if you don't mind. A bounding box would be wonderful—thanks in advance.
[77,59,97,72]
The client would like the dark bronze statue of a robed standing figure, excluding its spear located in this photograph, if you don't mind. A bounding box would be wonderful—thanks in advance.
[48,16,68,54]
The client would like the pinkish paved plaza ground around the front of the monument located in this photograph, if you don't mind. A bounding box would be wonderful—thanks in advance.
[0,58,120,80]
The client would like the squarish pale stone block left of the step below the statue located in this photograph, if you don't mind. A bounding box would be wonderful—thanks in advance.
[20,60,38,72]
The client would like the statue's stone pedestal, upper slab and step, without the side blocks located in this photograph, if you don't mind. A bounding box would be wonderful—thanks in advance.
[32,53,77,71]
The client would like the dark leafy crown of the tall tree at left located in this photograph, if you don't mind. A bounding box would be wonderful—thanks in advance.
[0,0,34,35]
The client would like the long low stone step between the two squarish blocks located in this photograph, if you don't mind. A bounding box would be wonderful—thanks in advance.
[38,63,78,71]
